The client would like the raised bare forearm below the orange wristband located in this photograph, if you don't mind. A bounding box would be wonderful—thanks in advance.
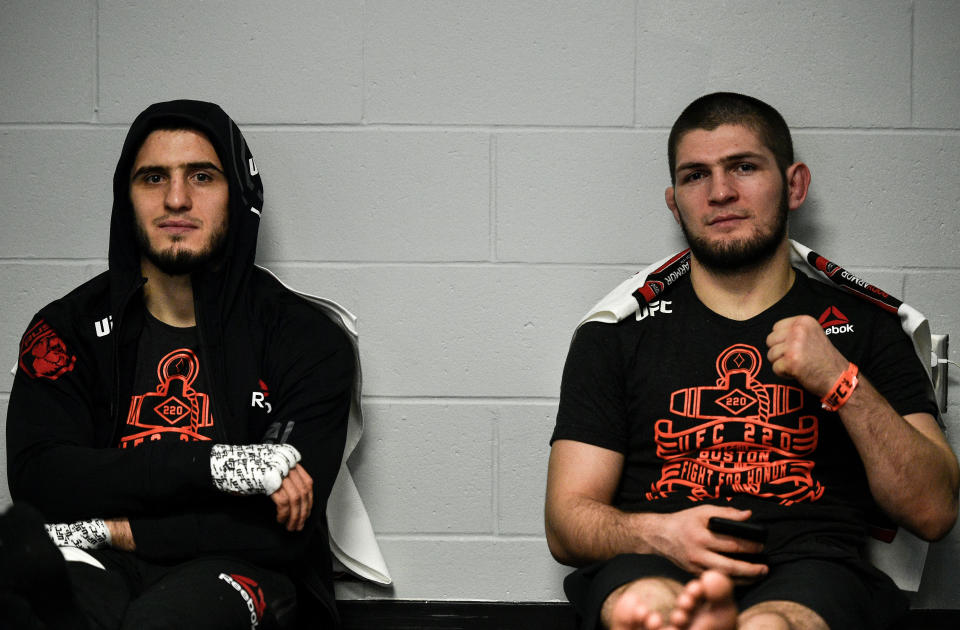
[839,375,960,540]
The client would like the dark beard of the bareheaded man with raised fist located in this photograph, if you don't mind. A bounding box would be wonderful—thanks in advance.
[680,186,790,274]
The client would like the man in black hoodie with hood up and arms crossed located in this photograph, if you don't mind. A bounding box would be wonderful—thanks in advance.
[7,101,356,628]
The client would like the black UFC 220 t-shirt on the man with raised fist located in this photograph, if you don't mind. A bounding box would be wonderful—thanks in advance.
[552,272,936,564]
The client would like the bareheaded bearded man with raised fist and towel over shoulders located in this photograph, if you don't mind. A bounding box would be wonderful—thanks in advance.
[546,93,960,630]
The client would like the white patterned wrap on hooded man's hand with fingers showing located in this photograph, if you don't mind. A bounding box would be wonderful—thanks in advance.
[210,444,300,496]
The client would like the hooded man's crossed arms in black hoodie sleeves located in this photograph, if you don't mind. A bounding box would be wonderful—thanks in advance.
[7,308,354,563]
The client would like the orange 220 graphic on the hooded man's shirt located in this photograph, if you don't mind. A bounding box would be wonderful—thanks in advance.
[120,348,213,448]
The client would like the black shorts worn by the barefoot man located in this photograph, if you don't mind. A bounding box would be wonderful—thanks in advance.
[563,554,909,630]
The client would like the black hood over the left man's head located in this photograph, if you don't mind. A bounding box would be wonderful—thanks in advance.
[109,100,263,308]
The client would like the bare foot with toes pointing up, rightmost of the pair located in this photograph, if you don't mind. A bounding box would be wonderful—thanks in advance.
[668,571,737,630]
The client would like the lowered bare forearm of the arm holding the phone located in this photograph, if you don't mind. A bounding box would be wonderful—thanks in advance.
[546,497,662,566]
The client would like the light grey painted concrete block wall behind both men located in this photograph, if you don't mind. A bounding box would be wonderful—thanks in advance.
[0,0,960,608]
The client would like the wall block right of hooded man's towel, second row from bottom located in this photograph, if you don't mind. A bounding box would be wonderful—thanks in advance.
[350,400,494,534]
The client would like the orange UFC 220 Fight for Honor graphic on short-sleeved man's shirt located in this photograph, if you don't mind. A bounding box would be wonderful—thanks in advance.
[646,344,824,505]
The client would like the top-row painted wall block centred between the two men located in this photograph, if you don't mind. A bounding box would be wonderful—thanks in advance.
[364,0,634,126]
